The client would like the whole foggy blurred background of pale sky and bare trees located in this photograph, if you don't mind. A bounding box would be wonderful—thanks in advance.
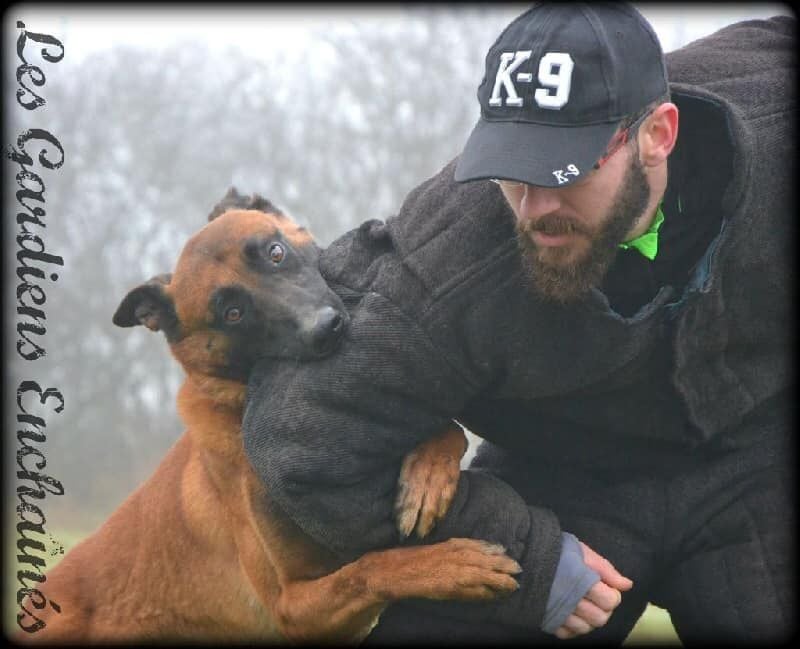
[3,3,791,642]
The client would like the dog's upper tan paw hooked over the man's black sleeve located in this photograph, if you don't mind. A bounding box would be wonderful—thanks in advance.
[394,422,467,538]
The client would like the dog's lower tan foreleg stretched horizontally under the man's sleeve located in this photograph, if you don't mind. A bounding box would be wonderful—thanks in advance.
[274,538,521,642]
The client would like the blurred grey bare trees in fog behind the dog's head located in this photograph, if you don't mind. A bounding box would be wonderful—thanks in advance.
[6,8,515,529]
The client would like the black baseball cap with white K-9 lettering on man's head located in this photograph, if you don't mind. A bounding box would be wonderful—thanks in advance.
[455,2,668,187]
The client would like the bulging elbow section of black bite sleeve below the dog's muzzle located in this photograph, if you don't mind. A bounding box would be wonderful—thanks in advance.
[243,293,464,560]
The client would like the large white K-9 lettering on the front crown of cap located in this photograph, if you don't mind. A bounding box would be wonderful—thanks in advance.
[489,50,575,110]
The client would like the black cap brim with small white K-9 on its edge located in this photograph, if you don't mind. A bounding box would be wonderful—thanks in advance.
[455,117,618,187]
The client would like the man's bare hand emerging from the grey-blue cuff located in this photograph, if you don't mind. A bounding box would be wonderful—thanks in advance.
[556,541,633,640]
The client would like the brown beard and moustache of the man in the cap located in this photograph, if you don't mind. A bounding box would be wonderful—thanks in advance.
[517,151,650,303]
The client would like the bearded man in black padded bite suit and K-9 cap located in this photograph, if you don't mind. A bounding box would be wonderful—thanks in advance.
[244,3,796,643]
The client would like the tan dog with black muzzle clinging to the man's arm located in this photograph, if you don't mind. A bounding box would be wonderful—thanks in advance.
[21,190,520,642]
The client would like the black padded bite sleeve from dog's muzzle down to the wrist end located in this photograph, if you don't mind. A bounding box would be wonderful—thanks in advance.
[242,293,561,629]
